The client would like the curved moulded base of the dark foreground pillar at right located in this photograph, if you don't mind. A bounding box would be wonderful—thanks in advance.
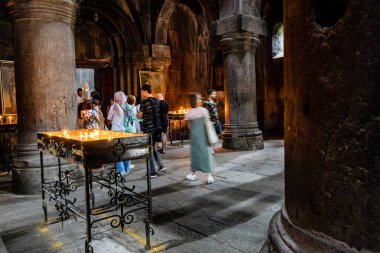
[268,205,364,253]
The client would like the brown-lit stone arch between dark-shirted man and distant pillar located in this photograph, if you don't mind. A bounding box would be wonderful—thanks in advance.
[154,0,212,110]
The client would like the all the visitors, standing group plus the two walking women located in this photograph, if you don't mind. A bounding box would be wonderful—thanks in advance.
[77,84,222,184]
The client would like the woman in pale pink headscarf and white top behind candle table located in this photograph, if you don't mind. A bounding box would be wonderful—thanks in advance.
[107,91,131,175]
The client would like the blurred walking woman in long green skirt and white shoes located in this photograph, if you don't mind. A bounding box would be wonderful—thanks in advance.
[185,94,215,184]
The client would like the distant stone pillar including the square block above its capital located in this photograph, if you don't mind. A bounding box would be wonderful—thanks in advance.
[211,0,266,150]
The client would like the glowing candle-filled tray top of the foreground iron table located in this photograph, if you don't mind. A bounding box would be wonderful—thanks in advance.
[37,130,150,168]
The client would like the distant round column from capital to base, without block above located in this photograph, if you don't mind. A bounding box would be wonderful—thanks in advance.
[221,33,264,150]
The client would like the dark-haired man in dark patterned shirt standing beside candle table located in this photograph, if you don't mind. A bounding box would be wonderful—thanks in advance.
[138,84,166,177]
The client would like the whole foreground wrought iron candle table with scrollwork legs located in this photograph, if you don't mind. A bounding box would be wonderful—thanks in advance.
[37,130,154,252]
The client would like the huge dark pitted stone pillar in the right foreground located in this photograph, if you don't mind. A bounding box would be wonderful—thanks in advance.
[269,0,380,253]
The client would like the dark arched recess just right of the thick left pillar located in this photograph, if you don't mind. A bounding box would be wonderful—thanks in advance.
[75,1,144,107]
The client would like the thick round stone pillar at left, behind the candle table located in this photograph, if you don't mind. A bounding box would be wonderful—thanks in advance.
[6,0,77,194]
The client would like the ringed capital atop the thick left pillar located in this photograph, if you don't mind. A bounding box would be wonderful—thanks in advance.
[6,0,78,28]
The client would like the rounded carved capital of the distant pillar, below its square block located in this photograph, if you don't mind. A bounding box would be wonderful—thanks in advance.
[220,33,260,53]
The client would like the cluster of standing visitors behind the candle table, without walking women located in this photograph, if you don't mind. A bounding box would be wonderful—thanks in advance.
[77,84,169,178]
